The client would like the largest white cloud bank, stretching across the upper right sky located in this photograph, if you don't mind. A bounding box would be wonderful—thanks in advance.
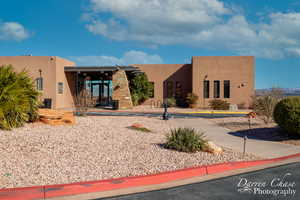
[84,0,300,59]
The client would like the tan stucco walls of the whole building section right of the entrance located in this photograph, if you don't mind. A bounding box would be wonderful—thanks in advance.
[134,56,255,107]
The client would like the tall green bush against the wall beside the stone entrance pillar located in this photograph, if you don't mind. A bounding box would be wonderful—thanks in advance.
[129,74,153,106]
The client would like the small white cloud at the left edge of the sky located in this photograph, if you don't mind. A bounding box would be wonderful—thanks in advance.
[0,22,29,41]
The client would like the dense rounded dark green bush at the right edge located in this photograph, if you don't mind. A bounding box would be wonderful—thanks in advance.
[274,97,300,135]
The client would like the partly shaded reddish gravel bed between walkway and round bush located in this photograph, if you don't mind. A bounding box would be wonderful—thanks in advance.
[209,117,300,146]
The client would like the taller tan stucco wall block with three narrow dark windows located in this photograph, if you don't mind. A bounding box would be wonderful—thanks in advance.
[192,56,255,107]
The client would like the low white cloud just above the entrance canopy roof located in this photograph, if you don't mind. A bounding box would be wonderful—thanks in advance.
[70,50,163,66]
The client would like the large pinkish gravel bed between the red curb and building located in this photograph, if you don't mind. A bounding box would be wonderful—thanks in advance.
[0,117,257,188]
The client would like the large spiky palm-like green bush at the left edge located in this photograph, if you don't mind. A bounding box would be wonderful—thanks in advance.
[0,65,39,130]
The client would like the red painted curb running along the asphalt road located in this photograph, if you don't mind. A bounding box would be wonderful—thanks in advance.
[0,153,300,200]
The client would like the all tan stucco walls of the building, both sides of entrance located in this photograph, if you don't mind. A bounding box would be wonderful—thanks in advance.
[0,56,255,109]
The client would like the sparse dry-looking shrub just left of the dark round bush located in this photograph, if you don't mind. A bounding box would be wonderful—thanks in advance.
[253,96,278,124]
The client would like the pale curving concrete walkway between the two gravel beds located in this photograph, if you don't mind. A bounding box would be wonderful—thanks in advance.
[168,118,300,158]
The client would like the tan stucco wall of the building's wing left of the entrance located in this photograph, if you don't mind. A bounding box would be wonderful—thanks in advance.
[0,56,74,108]
